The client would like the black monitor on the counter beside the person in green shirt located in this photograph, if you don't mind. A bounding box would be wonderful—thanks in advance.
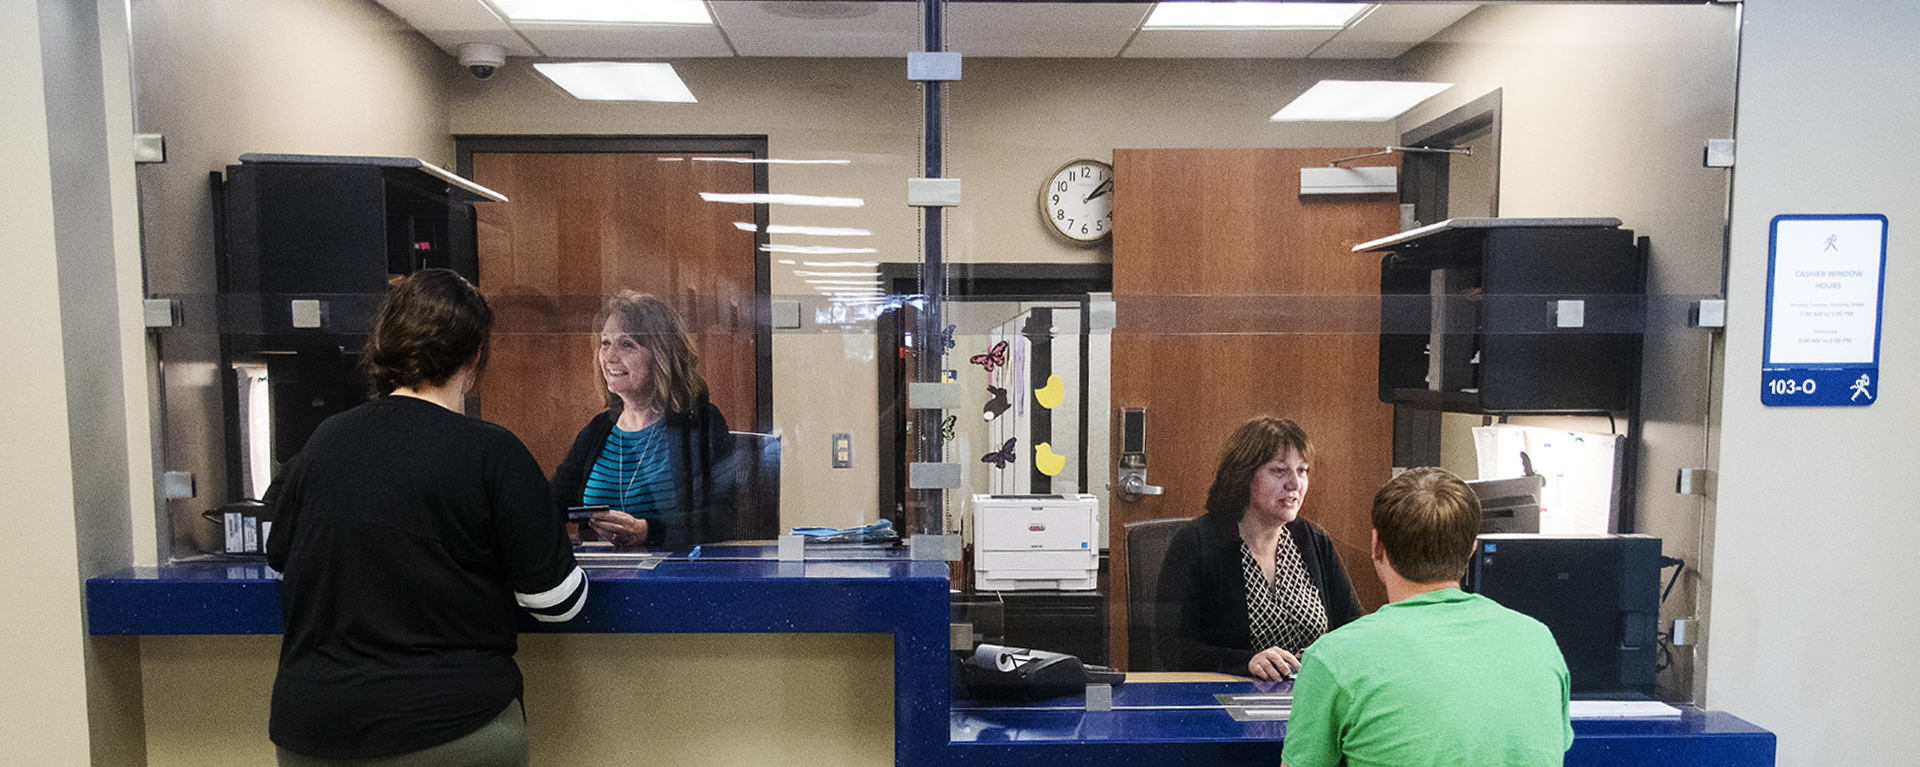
[1465,534,1661,700]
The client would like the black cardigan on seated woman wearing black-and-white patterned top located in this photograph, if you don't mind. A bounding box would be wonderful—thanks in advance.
[1156,511,1359,677]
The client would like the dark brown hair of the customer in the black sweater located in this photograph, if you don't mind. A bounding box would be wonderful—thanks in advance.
[361,269,493,394]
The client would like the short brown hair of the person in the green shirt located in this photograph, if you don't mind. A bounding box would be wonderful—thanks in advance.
[1373,467,1480,582]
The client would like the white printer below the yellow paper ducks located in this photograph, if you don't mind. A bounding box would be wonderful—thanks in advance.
[973,492,1100,590]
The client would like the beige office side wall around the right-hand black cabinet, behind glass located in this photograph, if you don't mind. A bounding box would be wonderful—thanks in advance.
[1400,4,1738,700]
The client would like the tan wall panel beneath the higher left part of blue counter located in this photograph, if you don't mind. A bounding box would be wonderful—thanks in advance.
[138,634,893,767]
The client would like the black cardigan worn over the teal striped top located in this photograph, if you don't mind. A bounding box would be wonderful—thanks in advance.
[551,400,737,548]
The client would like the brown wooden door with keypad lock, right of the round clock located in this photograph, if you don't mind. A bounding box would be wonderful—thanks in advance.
[1108,148,1400,663]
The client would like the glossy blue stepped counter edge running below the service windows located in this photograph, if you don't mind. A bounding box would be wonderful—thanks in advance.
[86,559,1774,767]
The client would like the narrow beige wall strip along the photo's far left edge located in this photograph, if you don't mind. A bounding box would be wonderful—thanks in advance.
[0,2,88,765]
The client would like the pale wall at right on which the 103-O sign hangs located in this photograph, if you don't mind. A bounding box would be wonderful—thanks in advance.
[1703,0,1920,765]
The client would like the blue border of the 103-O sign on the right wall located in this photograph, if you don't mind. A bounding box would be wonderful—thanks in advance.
[1761,213,1891,408]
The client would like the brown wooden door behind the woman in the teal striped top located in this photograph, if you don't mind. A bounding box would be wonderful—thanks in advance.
[470,152,766,473]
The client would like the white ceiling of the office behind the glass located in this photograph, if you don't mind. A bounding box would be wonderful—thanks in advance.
[376,0,1476,60]
